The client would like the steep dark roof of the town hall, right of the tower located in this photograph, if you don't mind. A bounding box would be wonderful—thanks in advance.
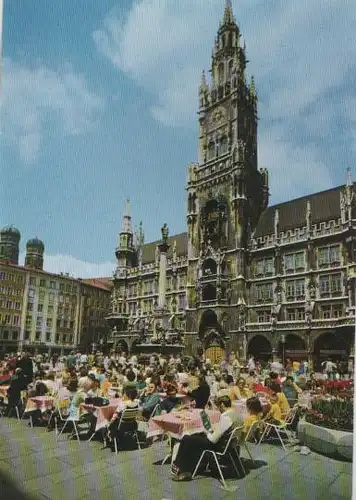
[254,186,344,238]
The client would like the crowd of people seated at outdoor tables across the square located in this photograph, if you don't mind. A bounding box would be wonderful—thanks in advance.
[0,352,352,481]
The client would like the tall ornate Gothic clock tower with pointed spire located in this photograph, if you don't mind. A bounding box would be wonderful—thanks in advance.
[187,0,268,356]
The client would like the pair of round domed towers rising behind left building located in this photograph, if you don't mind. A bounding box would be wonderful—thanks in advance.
[0,226,45,269]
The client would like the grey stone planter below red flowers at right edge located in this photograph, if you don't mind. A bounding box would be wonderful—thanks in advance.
[298,420,353,461]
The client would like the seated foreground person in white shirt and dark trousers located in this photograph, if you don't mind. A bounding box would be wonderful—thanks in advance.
[172,396,234,481]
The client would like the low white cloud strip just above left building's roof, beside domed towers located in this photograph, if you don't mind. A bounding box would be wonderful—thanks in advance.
[19,253,116,278]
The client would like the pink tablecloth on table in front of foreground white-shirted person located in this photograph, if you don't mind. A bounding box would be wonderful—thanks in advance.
[147,409,221,439]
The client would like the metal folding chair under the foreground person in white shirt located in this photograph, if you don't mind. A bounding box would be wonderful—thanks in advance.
[192,426,246,489]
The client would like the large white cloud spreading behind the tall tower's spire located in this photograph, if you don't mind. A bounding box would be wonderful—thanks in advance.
[93,0,356,201]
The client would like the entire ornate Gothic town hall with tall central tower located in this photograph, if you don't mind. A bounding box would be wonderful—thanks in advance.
[108,2,356,368]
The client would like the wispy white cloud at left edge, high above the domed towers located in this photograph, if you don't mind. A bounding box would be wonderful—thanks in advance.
[1,59,103,164]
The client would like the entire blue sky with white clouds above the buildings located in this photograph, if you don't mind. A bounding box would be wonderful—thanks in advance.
[0,0,356,277]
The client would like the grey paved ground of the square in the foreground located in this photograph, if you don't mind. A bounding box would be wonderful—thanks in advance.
[0,418,352,500]
